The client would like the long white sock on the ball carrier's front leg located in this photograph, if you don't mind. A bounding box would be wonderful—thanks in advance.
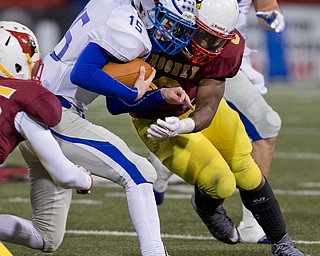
[126,183,164,256]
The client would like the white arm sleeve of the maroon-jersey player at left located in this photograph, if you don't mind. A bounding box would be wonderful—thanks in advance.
[14,112,91,190]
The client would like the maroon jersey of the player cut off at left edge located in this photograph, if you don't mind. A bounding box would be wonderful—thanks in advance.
[0,77,62,164]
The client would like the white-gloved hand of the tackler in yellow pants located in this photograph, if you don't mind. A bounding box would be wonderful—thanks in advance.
[147,116,180,140]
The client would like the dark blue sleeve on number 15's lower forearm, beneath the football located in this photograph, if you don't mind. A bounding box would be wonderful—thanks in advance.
[106,89,165,115]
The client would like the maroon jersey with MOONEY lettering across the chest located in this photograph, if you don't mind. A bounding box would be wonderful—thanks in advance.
[130,31,244,119]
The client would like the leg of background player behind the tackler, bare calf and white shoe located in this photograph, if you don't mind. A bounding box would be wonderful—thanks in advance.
[224,70,281,243]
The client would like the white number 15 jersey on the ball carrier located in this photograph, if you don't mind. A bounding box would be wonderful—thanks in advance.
[42,0,151,110]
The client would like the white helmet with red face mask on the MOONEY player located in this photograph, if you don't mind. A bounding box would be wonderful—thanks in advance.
[183,0,239,65]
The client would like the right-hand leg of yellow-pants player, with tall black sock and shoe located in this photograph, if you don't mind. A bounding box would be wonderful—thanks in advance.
[206,100,305,256]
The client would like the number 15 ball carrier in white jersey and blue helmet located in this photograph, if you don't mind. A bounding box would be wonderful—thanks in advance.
[20,0,197,256]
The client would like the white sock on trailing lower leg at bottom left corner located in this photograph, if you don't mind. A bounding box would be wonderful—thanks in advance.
[0,214,43,250]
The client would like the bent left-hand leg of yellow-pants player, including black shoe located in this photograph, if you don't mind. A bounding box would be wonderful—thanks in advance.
[133,116,239,243]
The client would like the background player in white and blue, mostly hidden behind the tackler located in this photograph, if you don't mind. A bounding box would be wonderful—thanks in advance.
[149,0,285,243]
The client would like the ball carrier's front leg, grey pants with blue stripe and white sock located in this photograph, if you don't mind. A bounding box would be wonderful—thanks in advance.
[52,108,164,255]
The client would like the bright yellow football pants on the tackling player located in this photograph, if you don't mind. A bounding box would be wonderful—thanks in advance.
[132,99,262,199]
